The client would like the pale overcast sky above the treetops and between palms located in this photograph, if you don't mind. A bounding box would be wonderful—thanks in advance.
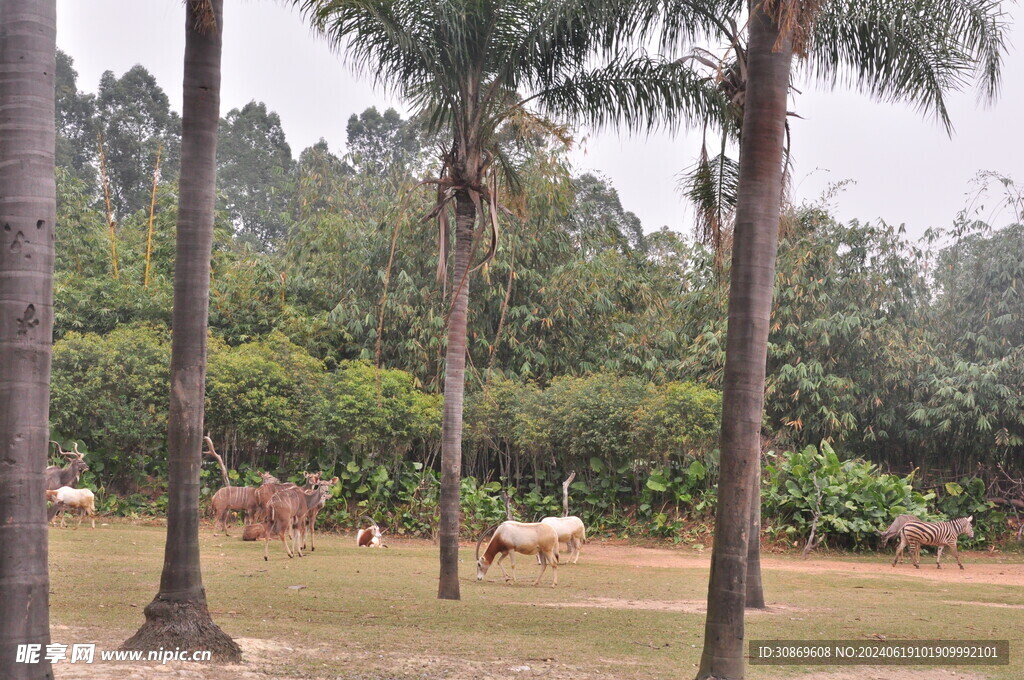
[57,0,1024,241]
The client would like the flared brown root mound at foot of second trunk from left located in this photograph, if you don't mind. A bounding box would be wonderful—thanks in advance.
[121,595,242,663]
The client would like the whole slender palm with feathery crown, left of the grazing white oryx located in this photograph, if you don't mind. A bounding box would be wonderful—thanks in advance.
[294,0,721,599]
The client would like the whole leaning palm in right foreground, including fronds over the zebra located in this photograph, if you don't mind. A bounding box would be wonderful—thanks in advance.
[697,0,1004,679]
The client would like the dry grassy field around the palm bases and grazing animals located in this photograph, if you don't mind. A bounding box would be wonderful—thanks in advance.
[50,524,1024,680]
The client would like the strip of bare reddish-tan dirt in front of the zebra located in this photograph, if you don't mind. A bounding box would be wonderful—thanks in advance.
[581,542,1024,586]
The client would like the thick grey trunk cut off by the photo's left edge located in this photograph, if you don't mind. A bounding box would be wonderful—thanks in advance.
[0,0,56,680]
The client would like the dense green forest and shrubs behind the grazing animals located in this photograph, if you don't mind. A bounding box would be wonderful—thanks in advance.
[51,54,1024,547]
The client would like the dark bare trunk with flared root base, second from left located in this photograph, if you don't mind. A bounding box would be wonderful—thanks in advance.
[123,0,242,662]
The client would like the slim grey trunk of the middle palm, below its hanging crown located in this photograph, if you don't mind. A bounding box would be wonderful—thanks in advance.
[437,189,476,600]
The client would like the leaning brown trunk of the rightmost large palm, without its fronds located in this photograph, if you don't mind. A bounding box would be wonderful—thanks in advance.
[697,2,793,680]
